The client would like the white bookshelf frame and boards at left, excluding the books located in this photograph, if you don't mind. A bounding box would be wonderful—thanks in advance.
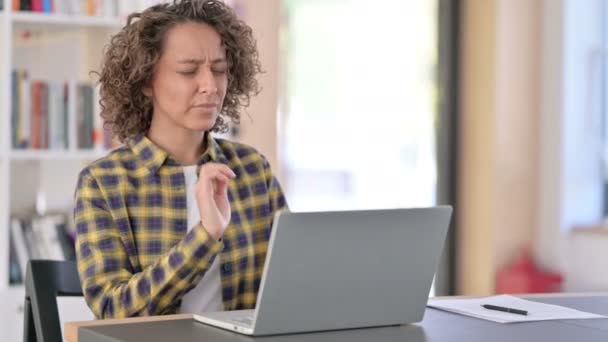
[0,0,141,341]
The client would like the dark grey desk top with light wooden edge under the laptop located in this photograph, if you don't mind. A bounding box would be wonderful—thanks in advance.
[66,294,608,342]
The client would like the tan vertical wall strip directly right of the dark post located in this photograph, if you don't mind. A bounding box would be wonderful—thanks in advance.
[456,0,496,294]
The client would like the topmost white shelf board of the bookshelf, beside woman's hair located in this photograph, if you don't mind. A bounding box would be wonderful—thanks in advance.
[10,12,122,28]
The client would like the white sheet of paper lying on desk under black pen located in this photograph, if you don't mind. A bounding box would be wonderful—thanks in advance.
[427,295,607,323]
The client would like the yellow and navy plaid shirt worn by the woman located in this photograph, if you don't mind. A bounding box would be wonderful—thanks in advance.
[74,134,286,318]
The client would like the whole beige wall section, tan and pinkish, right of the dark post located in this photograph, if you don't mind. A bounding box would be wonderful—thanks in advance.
[457,0,540,294]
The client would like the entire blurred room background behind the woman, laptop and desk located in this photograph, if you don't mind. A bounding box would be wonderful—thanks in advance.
[0,0,608,341]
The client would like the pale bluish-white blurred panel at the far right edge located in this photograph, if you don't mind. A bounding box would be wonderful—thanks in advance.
[561,0,605,231]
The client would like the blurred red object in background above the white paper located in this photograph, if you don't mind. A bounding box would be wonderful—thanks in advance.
[496,252,563,294]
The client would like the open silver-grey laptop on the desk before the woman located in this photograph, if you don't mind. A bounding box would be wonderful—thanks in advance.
[194,206,452,336]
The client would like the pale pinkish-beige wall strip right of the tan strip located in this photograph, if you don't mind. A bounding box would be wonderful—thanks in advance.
[494,0,541,276]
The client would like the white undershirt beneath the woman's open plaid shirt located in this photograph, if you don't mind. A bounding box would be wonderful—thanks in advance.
[179,165,223,314]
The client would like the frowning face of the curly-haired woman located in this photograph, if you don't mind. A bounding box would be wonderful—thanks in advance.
[144,22,228,131]
